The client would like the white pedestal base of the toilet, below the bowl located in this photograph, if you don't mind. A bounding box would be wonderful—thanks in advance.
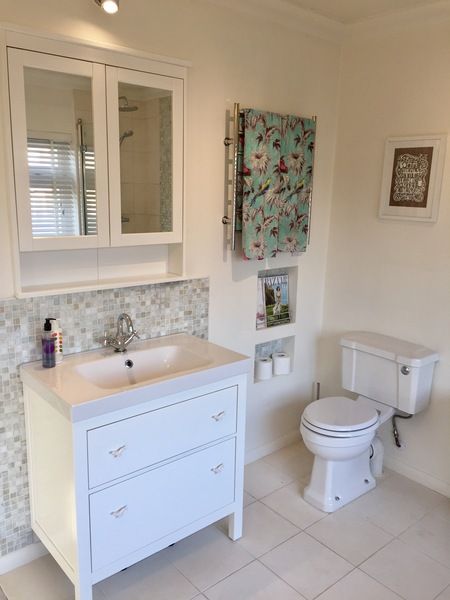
[303,448,377,512]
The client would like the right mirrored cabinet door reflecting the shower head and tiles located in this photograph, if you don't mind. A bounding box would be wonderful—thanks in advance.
[107,67,183,246]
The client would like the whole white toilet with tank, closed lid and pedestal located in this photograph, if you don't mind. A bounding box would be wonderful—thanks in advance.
[300,331,439,512]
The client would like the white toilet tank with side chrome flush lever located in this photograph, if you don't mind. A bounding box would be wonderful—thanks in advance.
[340,331,439,414]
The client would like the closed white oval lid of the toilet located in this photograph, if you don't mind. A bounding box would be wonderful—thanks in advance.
[302,396,378,431]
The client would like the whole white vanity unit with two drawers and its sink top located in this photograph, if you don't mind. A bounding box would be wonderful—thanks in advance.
[21,334,251,600]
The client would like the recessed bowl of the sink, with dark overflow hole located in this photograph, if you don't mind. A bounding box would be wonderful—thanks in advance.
[75,344,212,390]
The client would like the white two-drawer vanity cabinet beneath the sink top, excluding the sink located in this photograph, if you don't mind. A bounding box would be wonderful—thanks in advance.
[24,368,246,600]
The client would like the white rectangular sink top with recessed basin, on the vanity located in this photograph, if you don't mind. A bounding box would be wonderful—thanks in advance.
[20,333,251,422]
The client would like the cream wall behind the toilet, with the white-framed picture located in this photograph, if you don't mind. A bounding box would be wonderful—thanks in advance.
[320,17,450,493]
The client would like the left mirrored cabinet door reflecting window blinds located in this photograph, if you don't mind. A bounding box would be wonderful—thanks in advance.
[8,49,109,251]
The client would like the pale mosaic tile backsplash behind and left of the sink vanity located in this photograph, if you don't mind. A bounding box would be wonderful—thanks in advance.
[0,279,209,556]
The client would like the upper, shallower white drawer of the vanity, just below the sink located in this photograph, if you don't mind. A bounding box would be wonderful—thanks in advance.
[88,386,237,488]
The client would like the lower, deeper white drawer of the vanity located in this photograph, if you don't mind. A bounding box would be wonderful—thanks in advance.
[90,438,235,572]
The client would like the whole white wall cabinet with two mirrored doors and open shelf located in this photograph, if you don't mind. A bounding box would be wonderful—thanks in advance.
[2,30,188,295]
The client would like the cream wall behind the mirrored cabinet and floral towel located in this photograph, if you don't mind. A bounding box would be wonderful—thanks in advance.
[0,0,340,456]
